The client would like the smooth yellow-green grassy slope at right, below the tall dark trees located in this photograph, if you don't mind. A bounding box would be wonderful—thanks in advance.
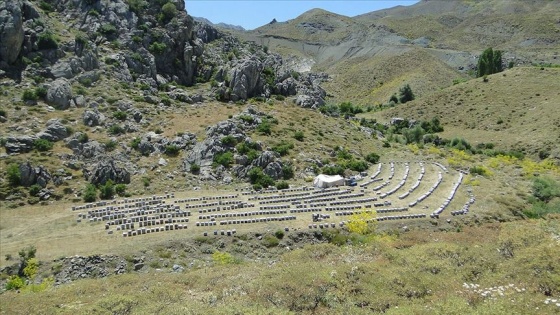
[368,68,560,156]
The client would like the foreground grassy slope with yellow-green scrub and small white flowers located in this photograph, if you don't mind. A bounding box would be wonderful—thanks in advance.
[0,218,560,314]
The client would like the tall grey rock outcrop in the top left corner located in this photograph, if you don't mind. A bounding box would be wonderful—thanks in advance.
[0,0,24,68]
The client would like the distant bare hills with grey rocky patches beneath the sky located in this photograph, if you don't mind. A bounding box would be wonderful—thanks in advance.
[240,0,560,104]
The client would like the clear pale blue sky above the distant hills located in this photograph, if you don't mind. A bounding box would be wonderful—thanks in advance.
[185,0,418,30]
